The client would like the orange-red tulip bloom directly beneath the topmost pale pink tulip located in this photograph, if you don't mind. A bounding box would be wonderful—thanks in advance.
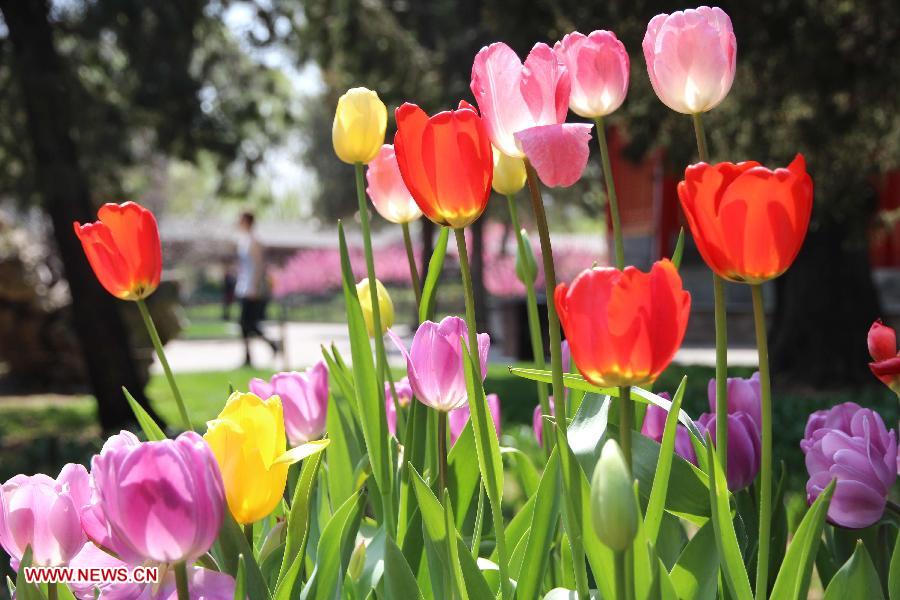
[678,154,813,283]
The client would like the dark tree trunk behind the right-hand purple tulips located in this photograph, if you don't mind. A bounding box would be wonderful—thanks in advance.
[772,211,879,389]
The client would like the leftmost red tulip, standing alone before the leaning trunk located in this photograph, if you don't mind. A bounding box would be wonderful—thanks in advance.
[73,202,162,300]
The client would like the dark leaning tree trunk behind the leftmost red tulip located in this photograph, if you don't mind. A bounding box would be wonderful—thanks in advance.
[0,0,162,430]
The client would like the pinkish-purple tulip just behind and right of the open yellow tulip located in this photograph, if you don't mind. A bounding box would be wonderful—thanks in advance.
[250,361,328,446]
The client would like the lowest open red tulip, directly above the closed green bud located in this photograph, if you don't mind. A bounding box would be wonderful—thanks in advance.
[554,259,691,386]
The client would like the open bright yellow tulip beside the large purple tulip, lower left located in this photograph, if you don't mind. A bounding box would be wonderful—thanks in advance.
[203,392,294,525]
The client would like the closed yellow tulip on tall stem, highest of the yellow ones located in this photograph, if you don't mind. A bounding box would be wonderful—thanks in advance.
[331,88,387,164]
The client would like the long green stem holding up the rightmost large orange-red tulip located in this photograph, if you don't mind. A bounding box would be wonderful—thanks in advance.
[750,283,772,598]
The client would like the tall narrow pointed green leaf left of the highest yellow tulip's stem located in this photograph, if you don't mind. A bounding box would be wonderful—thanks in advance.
[338,223,393,504]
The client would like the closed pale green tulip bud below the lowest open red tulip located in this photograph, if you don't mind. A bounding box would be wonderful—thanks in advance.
[591,440,639,552]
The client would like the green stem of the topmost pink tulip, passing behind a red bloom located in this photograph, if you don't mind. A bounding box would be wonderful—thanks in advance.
[693,113,728,482]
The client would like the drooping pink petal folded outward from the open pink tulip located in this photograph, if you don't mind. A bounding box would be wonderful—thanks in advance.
[515,123,593,187]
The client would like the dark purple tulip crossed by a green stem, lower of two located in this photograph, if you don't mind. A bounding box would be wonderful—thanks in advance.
[697,411,762,492]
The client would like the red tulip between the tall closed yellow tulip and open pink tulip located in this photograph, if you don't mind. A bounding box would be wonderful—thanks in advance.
[394,102,494,229]
